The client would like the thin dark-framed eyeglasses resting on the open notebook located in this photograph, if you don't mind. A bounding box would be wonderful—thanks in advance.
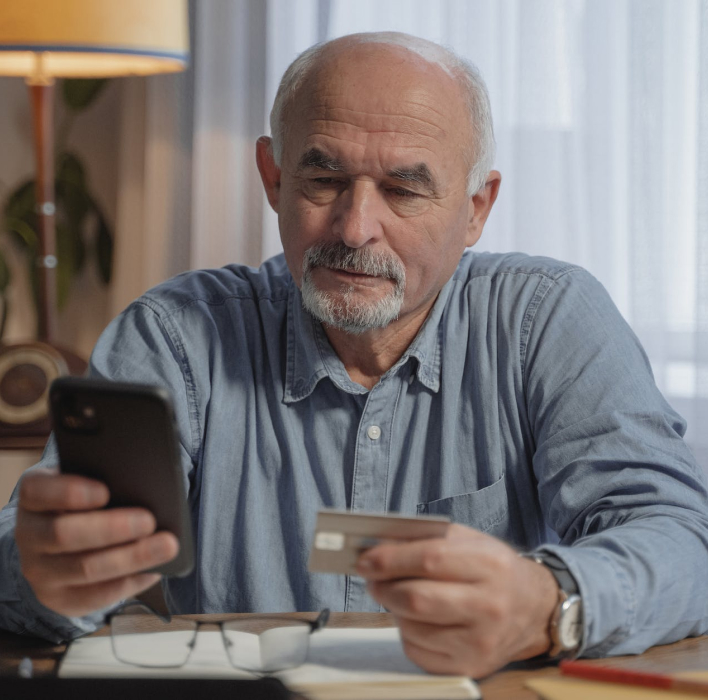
[106,600,329,674]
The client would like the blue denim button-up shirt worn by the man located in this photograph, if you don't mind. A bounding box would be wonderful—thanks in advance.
[0,251,708,655]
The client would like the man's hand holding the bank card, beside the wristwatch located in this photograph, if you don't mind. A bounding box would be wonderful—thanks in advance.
[358,525,558,678]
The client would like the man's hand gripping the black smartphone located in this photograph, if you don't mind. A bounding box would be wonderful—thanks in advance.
[15,471,179,616]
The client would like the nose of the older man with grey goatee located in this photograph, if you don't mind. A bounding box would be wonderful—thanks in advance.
[332,180,385,248]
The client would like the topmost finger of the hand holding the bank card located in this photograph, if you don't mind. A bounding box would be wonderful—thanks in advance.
[357,530,500,582]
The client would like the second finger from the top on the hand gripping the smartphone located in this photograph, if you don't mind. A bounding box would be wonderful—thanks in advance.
[16,508,155,554]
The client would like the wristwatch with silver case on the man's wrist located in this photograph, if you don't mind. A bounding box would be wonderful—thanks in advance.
[524,552,583,659]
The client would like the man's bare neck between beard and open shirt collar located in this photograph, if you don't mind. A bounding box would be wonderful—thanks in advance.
[322,299,435,389]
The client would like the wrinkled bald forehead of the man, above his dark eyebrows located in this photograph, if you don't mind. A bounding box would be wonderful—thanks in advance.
[286,44,470,165]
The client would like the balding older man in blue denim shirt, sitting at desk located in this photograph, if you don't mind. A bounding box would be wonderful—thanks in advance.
[0,33,708,676]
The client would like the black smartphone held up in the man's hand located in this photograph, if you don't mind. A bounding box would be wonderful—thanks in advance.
[49,377,194,576]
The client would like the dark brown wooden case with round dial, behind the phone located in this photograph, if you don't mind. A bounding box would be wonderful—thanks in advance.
[0,341,88,449]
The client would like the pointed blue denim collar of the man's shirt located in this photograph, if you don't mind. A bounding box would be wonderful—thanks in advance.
[283,279,453,404]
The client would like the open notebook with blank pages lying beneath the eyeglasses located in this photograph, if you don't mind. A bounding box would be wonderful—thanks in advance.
[59,627,481,700]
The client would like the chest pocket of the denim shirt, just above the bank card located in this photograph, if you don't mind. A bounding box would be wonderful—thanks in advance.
[417,476,509,539]
